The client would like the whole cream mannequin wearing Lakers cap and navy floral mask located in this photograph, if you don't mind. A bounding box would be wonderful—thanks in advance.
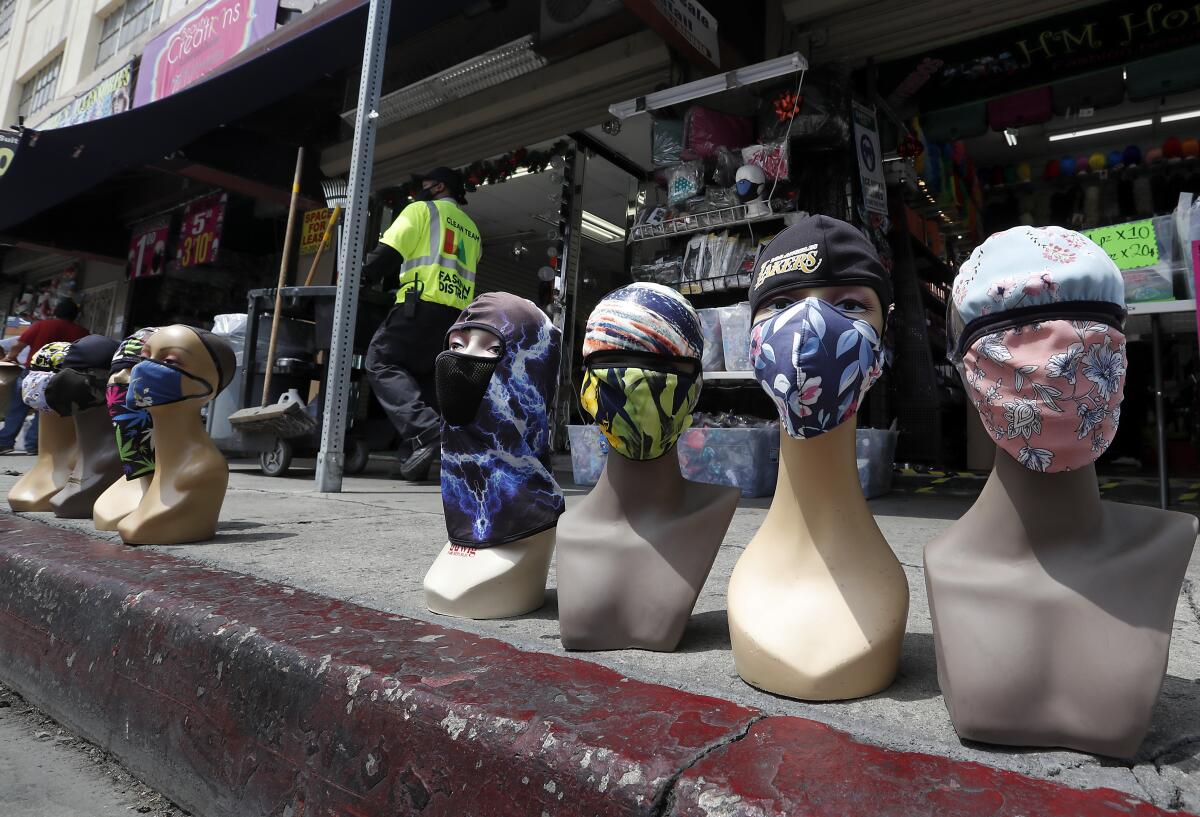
[727,216,908,701]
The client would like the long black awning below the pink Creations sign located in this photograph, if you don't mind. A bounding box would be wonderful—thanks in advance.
[0,0,472,230]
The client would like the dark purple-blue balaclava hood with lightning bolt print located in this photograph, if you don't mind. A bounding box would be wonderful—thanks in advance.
[442,293,565,547]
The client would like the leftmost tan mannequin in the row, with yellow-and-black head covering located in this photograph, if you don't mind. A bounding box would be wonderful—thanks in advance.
[8,342,79,512]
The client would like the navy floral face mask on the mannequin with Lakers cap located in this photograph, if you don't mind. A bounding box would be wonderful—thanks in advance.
[750,298,882,439]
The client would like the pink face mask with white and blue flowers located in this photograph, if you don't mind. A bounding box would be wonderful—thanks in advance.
[959,320,1126,473]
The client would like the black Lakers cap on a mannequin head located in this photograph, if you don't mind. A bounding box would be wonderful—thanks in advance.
[750,216,892,314]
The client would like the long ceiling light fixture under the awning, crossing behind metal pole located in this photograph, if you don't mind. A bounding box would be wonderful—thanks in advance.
[342,35,546,126]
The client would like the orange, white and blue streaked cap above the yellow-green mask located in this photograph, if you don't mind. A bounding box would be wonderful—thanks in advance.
[583,283,704,361]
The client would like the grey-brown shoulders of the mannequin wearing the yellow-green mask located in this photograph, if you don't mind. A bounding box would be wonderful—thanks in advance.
[558,446,739,651]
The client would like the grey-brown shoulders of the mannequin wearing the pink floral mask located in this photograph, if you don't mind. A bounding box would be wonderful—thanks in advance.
[925,467,1196,757]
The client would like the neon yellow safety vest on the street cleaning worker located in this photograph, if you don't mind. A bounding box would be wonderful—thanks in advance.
[379,199,484,310]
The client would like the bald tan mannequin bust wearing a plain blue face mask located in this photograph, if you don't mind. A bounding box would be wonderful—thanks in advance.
[118,324,235,545]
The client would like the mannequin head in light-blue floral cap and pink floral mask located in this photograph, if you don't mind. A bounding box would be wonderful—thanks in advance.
[947,227,1127,473]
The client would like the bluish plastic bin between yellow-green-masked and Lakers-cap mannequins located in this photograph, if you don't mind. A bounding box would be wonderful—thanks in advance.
[679,427,779,497]
